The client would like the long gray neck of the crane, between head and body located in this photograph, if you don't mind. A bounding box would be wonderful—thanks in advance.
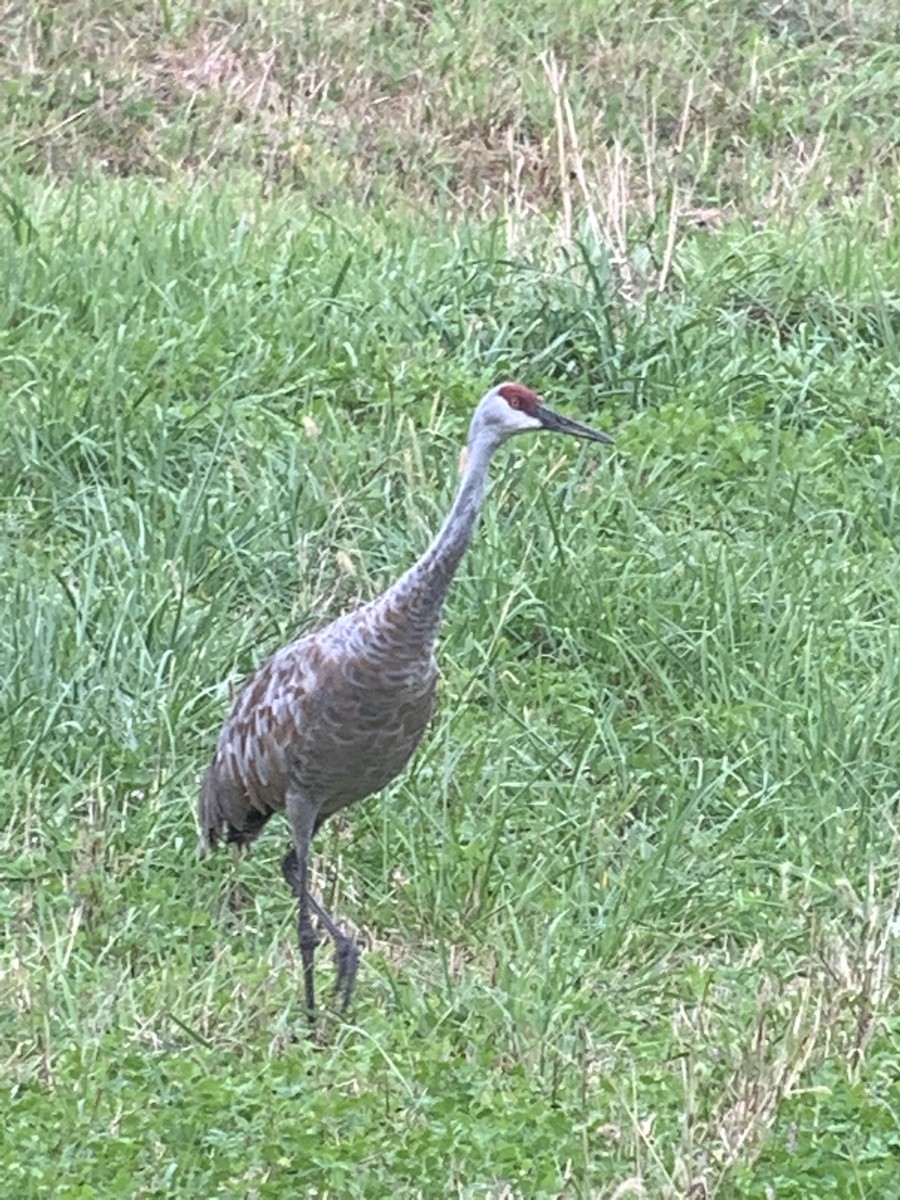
[382,433,499,646]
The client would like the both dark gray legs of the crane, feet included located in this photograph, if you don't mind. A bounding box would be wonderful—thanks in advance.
[281,796,359,1013]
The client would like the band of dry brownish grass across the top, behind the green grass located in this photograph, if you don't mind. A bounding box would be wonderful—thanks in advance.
[0,0,895,229]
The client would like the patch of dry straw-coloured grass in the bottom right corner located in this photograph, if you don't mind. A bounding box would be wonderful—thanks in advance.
[623,872,900,1198]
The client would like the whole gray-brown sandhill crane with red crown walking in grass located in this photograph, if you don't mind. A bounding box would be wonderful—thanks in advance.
[199,383,612,1014]
